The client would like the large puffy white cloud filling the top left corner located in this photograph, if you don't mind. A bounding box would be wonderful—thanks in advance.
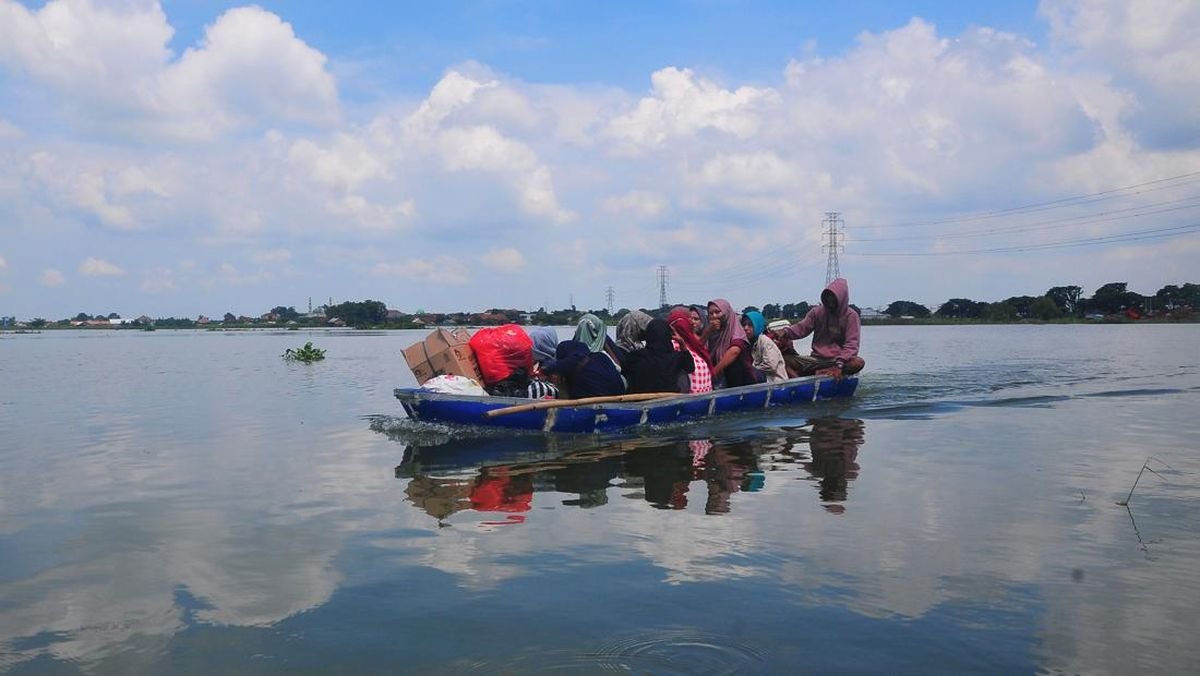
[0,0,338,140]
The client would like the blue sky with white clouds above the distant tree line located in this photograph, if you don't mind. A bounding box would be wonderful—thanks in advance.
[0,0,1200,319]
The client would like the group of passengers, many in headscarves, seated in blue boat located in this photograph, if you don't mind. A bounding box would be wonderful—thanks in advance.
[511,279,865,399]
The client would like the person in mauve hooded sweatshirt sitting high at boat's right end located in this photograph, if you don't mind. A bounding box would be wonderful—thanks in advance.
[781,277,866,378]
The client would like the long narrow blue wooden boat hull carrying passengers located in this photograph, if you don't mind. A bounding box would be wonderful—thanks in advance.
[395,376,858,433]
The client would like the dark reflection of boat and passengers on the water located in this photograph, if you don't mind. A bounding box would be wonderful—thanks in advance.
[396,418,865,526]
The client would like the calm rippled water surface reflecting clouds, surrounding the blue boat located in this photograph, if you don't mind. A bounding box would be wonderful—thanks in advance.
[0,325,1200,674]
